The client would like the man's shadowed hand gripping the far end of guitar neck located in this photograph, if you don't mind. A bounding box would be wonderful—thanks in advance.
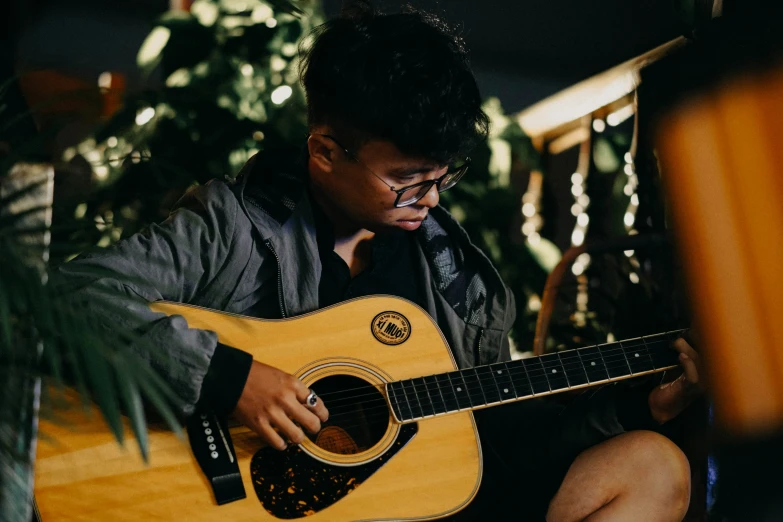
[647,337,705,424]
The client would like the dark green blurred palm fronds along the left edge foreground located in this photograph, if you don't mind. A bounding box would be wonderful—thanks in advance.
[0,95,179,522]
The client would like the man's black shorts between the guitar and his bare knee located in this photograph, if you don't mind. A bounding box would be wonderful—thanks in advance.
[443,399,595,522]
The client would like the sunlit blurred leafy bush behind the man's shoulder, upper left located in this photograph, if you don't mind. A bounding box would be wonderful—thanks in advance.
[62,0,321,246]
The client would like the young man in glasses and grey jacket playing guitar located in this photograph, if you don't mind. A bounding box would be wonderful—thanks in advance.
[55,8,698,521]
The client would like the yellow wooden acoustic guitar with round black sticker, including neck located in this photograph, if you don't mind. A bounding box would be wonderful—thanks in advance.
[35,296,680,522]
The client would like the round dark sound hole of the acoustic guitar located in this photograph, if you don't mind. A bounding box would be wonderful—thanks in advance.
[308,375,389,455]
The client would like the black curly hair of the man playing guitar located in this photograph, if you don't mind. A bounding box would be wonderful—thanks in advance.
[300,1,489,164]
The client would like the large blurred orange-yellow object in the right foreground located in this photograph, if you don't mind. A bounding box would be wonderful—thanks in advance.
[657,66,783,436]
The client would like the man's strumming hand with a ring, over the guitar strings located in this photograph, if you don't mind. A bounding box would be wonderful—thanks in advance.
[234,361,329,450]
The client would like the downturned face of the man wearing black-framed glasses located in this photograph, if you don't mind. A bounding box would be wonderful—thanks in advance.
[310,135,447,232]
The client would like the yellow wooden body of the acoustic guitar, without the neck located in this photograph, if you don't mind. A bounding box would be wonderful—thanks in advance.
[35,297,481,522]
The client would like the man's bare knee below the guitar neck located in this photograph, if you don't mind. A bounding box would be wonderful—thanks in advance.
[547,431,690,522]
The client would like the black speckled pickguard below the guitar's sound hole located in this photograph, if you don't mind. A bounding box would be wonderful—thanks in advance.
[250,423,419,519]
